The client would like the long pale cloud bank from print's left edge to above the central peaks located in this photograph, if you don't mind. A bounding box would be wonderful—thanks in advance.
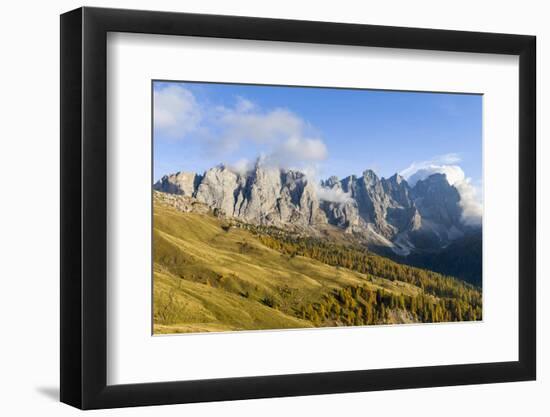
[154,85,328,168]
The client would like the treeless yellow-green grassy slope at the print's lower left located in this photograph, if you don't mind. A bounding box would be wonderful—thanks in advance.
[153,202,420,333]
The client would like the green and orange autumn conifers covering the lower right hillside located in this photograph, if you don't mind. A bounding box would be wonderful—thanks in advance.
[237,225,482,325]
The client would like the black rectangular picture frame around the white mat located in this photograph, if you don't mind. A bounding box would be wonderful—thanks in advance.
[60,7,536,409]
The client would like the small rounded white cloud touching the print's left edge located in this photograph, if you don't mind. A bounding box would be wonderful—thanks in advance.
[153,84,202,139]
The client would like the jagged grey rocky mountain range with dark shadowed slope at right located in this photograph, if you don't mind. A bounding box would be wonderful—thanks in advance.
[153,161,481,285]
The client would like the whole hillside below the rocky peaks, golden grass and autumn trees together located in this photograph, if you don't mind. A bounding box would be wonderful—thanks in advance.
[153,192,481,333]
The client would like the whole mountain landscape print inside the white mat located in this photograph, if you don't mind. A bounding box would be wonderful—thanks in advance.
[152,81,483,334]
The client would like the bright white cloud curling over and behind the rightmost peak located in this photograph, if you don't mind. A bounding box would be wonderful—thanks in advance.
[400,154,483,225]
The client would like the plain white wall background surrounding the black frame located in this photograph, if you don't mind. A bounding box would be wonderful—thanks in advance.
[0,0,550,417]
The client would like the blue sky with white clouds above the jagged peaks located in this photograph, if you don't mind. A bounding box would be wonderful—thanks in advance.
[153,82,482,184]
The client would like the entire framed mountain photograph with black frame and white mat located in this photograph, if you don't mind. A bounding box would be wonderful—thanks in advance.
[61,7,536,409]
